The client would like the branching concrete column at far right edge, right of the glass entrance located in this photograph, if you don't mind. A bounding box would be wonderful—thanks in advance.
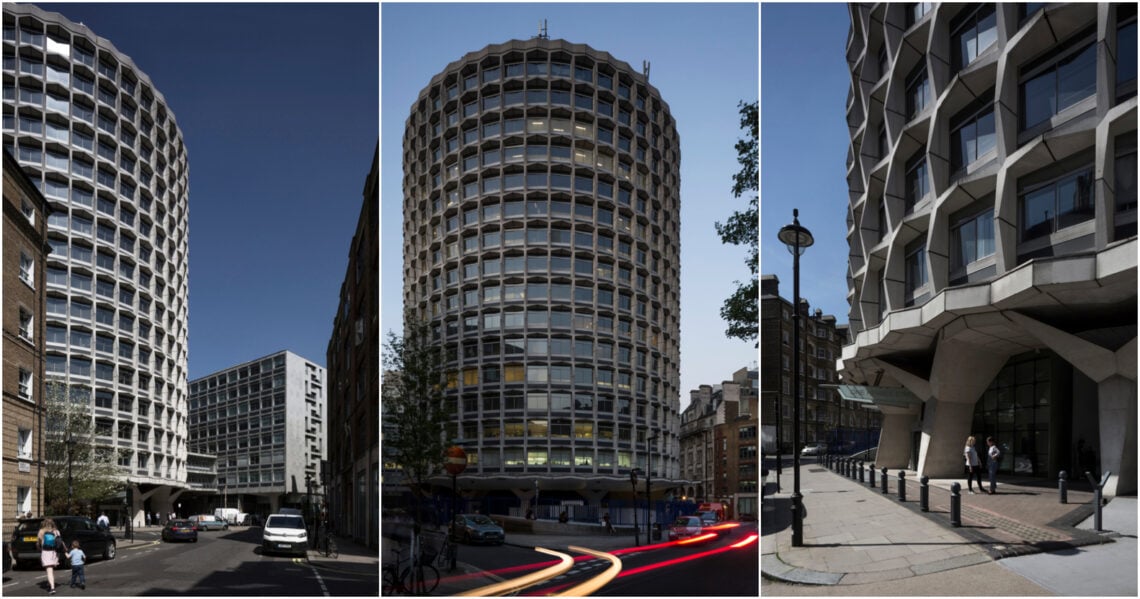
[1004,311,1137,496]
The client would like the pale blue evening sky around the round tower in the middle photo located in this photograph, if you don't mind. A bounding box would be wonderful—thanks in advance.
[381,2,759,405]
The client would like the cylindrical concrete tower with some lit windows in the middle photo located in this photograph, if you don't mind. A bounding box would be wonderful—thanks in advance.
[404,39,681,488]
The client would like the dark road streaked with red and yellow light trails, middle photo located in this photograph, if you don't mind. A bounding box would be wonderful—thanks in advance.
[451,523,760,597]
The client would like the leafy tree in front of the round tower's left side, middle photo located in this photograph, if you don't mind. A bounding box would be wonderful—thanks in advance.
[381,313,448,529]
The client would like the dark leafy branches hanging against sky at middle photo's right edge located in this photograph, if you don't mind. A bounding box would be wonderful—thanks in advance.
[716,102,760,341]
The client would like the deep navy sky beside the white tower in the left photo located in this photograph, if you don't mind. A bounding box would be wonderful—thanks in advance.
[38,2,380,379]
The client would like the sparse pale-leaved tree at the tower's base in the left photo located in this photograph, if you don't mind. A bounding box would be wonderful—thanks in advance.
[43,381,123,513]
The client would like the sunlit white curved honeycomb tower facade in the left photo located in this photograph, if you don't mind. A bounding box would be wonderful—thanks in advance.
[3,3,188,486]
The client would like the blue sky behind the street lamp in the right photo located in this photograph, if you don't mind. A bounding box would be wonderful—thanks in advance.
[760,3,850,324]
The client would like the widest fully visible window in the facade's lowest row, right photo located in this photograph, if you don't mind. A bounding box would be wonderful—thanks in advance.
[1019,167,1093,242]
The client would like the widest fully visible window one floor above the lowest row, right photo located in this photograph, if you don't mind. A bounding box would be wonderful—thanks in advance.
[1020,31,1097,130]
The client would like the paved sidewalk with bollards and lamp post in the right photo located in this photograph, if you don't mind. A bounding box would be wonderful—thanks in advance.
[762,462,1110,584]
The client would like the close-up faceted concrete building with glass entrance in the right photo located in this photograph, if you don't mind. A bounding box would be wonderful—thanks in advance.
[838,2,1137,494]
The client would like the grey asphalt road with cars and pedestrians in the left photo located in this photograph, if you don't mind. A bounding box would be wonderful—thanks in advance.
[3,528,377,597]
